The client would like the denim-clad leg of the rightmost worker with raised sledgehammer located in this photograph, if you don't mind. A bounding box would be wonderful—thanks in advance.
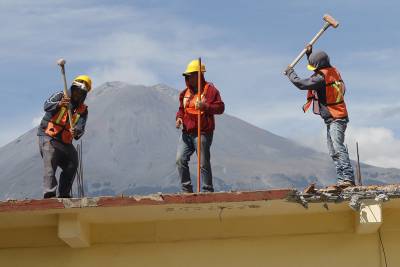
[331,120,354,184]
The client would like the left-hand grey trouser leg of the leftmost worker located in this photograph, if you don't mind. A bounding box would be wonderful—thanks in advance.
[39,136,58,198]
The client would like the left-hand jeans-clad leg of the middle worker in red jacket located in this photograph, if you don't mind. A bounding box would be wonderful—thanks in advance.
[176,133,195,193]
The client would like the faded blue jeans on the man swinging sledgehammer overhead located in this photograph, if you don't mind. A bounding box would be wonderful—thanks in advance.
[326,119,354,183]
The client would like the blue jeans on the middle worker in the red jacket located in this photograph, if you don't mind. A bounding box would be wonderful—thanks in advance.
[176,132,214,193]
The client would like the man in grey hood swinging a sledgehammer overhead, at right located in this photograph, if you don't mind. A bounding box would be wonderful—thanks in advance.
[286,45,355,188]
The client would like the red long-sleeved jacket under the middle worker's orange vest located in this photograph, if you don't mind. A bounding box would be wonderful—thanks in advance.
[176,82,225,134]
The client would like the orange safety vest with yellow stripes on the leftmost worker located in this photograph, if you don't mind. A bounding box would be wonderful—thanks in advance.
[45,104,87,144]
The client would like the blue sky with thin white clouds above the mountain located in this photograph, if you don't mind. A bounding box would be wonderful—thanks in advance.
[0,0,400,168]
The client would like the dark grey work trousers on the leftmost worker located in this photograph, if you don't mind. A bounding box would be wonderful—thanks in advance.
[39,136,78,198]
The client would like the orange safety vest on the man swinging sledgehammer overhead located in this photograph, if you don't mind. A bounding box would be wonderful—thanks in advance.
[303,67,348,119]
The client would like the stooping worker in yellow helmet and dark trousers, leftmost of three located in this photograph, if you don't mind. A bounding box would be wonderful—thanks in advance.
[37,75,92,198]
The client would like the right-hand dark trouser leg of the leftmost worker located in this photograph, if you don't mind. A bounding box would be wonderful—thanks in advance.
[58,144,78,198]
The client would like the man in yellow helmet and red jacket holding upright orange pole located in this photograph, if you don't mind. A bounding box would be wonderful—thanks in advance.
[176,59,225,193]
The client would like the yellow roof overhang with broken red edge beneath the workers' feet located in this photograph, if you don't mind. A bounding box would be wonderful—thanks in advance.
[0,185,400,248]
